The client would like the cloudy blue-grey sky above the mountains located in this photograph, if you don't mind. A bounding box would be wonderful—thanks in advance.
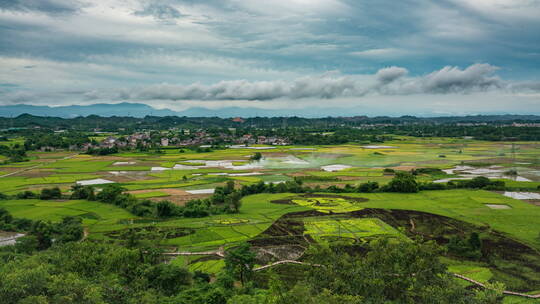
[0,0,540,116]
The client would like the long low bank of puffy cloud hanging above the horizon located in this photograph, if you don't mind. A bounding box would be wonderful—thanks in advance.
[96,64,510,101]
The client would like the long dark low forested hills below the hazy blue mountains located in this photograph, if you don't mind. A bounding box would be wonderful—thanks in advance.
[0,114,540,130]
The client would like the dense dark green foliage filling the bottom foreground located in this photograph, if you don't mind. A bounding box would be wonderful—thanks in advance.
[0,240,501,304]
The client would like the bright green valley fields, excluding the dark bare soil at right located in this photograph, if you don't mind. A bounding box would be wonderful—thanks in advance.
[0,137,540,303]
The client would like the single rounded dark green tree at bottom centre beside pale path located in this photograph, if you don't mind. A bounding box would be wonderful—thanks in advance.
[225,243,255,285]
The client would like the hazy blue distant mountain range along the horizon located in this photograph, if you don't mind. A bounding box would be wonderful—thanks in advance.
[0,102,540,120]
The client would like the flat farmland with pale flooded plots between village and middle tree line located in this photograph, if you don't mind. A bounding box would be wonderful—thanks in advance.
[0,137,540,193]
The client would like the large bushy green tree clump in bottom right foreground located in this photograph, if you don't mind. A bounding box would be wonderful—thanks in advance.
[307,239,480,304]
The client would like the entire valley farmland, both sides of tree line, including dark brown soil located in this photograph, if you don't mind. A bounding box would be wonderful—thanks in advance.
[0,137,540,303]
